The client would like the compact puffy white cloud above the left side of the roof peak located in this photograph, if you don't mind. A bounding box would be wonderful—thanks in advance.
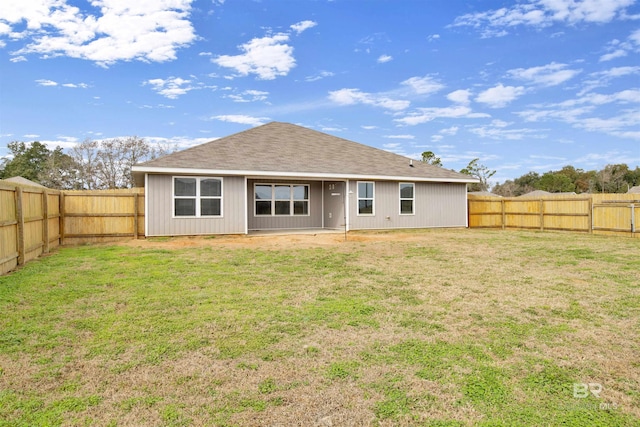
[212,33,296,80]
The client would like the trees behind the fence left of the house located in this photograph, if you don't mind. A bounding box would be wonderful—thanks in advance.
[0,136,170,190]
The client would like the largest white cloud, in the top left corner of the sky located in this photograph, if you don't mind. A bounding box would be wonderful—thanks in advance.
[0,0,196,66]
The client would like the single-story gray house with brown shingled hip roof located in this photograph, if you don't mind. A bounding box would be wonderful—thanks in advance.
[133,122,477,236]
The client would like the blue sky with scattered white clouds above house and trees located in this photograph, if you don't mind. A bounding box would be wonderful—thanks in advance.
[0,0,640,183]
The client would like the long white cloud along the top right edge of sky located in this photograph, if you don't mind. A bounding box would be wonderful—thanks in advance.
[451,0,635,37]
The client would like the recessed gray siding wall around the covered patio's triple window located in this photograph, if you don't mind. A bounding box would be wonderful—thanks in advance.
[247,179,322,230]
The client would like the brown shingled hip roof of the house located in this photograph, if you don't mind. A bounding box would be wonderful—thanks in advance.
[133,122,477,182]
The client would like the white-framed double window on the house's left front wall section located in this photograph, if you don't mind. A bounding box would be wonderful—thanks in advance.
[173,177,222,218]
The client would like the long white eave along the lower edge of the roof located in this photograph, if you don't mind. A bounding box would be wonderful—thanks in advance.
[132,166,479,184]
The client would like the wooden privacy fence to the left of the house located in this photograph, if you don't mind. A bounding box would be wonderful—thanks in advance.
[0,183,144,274]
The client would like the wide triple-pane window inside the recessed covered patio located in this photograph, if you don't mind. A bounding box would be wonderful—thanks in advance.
[255,184,309,216]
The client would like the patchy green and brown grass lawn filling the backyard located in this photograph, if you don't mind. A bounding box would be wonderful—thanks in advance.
[0,230,640,426]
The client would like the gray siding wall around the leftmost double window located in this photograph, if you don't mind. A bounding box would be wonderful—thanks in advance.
[145,175,247,236]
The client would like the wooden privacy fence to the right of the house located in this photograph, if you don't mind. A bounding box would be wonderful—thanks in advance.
[468,194,640,237]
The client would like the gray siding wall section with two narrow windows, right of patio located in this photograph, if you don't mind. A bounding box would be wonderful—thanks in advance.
[349,181,467,230]
